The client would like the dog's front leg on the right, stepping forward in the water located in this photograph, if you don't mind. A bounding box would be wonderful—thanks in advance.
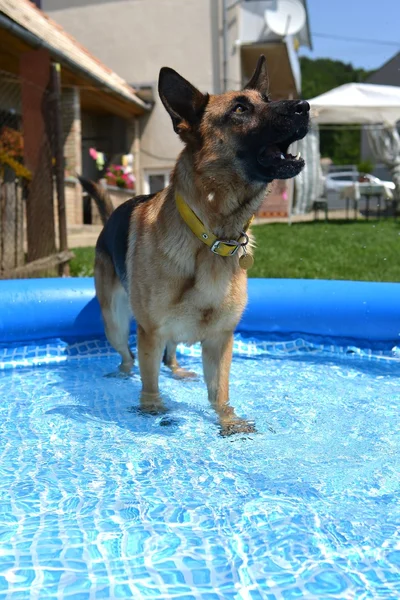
[202,332,255,435]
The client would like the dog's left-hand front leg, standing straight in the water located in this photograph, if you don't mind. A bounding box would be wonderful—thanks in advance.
[137,325,166,414]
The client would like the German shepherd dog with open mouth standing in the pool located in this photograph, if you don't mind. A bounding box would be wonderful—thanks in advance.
[81,56,310,435]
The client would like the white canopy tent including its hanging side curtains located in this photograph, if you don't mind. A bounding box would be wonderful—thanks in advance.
[291,83,400,214]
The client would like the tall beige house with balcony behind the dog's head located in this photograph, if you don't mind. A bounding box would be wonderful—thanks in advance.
[42,0,311,217]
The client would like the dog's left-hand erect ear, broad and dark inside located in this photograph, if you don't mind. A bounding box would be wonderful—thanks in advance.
[158,67,209,133]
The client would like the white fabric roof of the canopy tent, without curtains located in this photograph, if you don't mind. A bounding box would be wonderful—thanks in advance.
[309,83,400,126]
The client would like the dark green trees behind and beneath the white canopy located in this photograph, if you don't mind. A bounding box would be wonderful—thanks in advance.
[300,56,372,165]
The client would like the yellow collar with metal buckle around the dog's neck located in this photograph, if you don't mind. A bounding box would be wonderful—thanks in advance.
[175,194,254,256]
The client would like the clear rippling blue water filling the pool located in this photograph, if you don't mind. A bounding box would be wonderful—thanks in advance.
[0,338,400,600]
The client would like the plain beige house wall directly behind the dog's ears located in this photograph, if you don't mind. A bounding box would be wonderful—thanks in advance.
[42,0,225,182]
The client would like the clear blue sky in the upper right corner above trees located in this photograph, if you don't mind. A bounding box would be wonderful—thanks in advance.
[300,0,400,71]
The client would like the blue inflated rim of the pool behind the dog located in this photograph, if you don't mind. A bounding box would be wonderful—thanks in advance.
[0,277,400,347]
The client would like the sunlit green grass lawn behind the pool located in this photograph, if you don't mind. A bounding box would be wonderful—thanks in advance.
[70,219,400,281]
